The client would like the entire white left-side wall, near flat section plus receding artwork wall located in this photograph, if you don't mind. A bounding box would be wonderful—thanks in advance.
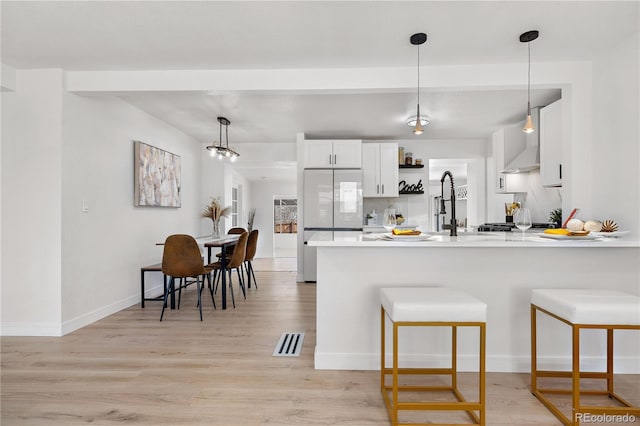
[2,70,203,335]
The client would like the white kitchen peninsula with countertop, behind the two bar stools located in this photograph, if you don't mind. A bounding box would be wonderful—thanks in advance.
[308,232,640,373]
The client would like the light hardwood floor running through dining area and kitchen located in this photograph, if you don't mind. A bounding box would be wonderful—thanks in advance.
[1,259,640,426]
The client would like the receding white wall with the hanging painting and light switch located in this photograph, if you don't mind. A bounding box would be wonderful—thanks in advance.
[62,94,204,331]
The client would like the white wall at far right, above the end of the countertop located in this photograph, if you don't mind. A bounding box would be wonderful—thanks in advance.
[592,33,640,237]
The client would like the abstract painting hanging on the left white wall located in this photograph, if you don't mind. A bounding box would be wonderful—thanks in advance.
[133,141,181,207]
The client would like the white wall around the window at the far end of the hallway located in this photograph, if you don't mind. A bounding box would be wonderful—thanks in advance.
[250,180,302,257]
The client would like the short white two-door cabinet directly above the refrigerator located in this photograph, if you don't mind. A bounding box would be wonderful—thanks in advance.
[304,140,362,169]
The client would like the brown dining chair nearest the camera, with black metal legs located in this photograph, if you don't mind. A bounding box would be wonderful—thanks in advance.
[160,234,216,321]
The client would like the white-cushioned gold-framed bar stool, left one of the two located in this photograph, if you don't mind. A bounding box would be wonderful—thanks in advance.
[380,287,487,426]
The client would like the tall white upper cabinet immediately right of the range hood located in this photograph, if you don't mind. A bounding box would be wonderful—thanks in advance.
[540,100,562,186]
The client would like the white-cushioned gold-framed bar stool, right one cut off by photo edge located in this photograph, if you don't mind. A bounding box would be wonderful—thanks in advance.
[531,289,640,425]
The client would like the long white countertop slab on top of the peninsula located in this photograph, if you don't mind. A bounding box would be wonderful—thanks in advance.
[307,232,640,248]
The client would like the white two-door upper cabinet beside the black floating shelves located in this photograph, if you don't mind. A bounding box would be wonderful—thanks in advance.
[362,142,398,198]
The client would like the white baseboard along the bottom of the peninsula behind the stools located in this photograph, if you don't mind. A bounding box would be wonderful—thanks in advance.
[315,348,640,374]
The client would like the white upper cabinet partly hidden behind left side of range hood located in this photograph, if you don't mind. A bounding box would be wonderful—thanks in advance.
[492,124,526,194]
